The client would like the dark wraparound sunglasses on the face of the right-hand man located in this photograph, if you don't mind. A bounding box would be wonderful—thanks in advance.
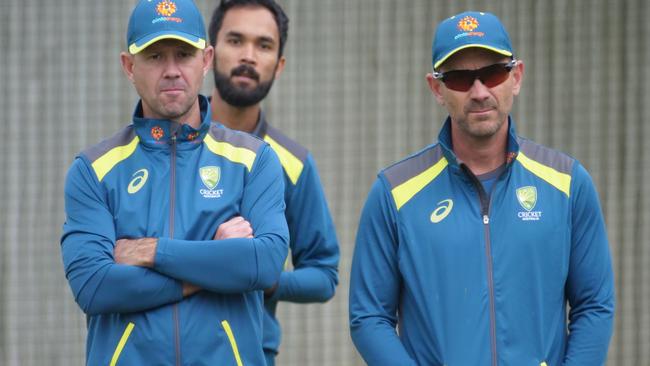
[433,59,517,92]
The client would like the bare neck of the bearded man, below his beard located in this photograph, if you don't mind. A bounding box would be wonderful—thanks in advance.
[210,88,260,132]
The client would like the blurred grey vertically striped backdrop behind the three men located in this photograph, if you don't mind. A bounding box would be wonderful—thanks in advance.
[0,0,650,366]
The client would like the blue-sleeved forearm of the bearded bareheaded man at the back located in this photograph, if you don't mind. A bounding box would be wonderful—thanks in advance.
[271,267,336,303]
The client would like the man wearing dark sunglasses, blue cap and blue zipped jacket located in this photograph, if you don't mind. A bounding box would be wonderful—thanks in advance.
[350,12,614,366]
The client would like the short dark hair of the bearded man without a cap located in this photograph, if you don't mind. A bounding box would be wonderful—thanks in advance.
[208,0,289,57]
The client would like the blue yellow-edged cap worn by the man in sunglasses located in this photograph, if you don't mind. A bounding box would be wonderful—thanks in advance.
[432,11,513,70]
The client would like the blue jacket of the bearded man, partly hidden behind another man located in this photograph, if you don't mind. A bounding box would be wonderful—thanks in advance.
[248,112,339,354]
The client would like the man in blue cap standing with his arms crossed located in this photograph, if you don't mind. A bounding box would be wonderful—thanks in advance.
[61,0,289,365]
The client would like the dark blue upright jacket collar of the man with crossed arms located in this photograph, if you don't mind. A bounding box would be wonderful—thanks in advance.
[133,94,210,146]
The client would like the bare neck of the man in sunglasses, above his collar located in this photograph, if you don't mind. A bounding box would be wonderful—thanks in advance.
[451,123,508,175]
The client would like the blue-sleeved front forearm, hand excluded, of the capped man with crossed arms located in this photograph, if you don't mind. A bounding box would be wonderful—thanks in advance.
[154,234,286,293]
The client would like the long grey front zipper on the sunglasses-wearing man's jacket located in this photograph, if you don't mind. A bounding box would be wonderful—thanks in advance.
[461,164,497,366]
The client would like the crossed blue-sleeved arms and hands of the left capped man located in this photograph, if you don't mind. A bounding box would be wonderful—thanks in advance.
[61,147,288,315]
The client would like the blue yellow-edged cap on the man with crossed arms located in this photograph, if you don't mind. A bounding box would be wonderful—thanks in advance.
[126,0,206,55]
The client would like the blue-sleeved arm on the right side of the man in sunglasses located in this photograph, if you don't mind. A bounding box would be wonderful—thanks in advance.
[564,167,615,365]
